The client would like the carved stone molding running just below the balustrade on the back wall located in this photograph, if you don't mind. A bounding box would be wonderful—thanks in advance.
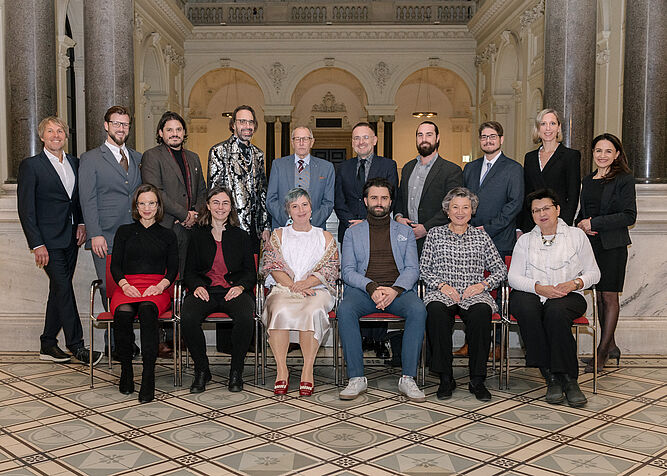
[192,30,472,41]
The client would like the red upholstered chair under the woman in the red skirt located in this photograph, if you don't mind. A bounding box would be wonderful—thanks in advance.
[88,254,181,388]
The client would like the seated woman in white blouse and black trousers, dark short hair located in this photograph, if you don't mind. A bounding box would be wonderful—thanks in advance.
[509,189,600,407]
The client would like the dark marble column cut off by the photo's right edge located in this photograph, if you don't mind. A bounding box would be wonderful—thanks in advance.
[623,0,667,183]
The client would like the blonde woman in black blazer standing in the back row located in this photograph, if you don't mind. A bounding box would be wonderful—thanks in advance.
[519,109,581,233]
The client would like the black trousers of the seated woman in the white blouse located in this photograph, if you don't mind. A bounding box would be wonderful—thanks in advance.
[510,289,586,379]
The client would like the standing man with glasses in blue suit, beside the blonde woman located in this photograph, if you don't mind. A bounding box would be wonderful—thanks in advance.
[463,121,524,257]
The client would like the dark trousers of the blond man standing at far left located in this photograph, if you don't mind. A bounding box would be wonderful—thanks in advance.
[39,232,83,352]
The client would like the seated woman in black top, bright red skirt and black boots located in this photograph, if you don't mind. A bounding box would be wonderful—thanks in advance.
[111,184,178,403]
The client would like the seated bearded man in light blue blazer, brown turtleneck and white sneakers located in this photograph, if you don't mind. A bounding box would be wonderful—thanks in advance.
[337,178,426,402]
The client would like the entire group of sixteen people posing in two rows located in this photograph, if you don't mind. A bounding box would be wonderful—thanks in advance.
[18,105,636,406]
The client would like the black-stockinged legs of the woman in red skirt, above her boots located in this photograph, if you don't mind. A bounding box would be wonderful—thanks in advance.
[113,301,160,371]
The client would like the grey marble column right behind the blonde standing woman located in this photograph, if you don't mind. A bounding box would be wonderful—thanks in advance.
[544,0,597,173]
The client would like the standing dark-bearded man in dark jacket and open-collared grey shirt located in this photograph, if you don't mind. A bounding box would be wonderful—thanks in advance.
[394,121,463,255]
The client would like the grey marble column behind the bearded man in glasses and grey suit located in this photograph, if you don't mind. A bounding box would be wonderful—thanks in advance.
[83,0,135,149]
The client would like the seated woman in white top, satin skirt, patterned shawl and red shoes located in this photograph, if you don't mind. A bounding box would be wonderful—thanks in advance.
[262,188,339,396]
